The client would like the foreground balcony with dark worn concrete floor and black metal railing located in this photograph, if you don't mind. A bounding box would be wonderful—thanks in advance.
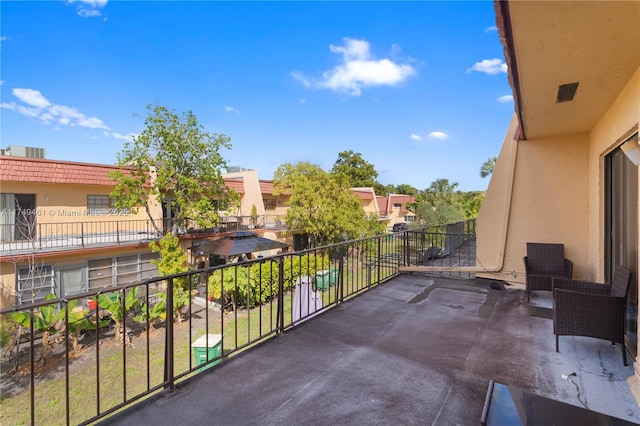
[0,225,640,425]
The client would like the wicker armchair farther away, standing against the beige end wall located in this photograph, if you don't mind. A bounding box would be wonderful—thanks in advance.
[522,243,573,301]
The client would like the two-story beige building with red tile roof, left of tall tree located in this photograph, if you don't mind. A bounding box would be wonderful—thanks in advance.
[0,155,162,307]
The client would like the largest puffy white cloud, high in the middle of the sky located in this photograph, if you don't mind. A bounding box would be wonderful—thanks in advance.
[291,38,416,96]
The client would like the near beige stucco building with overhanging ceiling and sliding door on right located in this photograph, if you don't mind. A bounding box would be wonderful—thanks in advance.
[477,1,640,398]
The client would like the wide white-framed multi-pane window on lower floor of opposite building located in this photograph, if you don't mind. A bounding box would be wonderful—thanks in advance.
[88,253,158,289]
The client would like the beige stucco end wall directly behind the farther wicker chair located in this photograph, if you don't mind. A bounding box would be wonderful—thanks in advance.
[478,116,589,285]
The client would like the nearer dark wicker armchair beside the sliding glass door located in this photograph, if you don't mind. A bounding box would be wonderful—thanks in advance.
[553,266,631,366]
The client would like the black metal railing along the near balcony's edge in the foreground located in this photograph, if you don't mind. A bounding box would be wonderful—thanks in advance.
[0,224,475,424]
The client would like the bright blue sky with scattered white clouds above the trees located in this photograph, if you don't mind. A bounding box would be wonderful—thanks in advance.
[0,0,513,191]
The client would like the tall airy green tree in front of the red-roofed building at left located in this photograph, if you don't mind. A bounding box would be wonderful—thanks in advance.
[109,105,237,234]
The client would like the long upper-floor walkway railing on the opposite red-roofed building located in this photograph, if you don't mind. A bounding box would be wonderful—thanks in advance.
[0,215,285,256]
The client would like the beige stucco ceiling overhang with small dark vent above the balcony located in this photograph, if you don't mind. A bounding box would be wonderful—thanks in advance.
[499,1,640,139]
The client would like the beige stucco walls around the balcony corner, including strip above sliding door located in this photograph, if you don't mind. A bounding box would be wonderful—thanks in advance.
[477,70,640,285]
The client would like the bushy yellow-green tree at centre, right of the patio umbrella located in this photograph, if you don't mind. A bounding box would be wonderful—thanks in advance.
[273,162,382,243]
